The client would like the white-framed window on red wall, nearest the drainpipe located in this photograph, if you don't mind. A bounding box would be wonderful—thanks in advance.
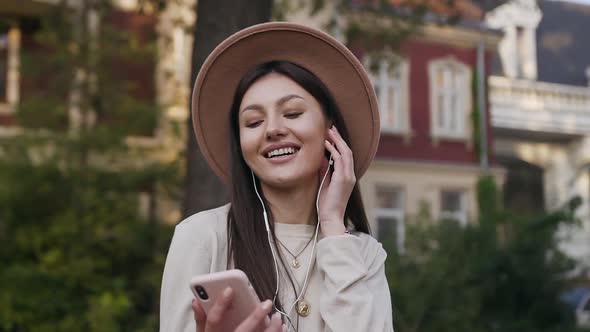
[428,58,471,139]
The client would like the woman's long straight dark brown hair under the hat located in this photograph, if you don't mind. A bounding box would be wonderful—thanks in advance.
[227,61,370,310]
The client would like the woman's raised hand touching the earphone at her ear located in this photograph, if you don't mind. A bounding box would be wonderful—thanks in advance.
[319,126,356,236]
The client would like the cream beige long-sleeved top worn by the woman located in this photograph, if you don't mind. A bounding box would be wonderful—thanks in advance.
[160,205,393,332]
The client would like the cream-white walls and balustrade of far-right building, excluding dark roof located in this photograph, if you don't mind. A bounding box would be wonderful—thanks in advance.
[486,0,590,267]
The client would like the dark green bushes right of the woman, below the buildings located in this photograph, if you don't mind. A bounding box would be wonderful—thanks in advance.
[386,176,575,332]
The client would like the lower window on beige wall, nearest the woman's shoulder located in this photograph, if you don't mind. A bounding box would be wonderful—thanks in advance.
[375,186,405,254]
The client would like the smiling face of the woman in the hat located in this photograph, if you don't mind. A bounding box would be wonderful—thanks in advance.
[239,73,328,188]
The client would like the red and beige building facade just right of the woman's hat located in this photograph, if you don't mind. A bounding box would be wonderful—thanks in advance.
[286,1,503,253]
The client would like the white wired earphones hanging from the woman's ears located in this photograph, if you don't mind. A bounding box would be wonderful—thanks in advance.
[250,154,334,331]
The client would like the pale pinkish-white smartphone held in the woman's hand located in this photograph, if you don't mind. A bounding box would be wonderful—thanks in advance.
[190,269,260,331]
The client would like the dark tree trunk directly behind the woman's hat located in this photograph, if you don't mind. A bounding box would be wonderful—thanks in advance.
[183,0,272,217]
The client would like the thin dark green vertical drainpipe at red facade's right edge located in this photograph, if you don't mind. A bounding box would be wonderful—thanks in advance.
[477,38,489,173]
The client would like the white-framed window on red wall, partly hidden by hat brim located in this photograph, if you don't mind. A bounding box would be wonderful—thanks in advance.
[365,56,410,133]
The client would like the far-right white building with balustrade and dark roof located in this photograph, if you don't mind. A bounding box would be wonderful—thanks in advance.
[486,0,590,267]
